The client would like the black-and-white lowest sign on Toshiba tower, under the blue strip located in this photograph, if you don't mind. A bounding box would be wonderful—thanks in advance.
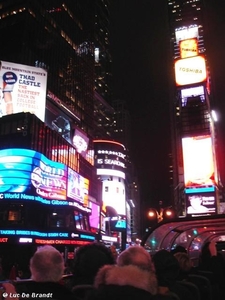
[186,192,216,216]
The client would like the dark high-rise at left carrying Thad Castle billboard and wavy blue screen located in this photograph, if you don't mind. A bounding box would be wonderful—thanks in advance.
[0,0,106,268]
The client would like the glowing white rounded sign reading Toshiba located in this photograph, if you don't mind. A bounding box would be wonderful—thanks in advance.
[175,56,207,86]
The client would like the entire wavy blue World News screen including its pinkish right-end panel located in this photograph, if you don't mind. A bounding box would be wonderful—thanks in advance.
[0,148,91,209]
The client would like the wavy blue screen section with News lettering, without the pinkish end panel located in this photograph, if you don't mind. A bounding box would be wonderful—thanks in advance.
[0,148,67,201]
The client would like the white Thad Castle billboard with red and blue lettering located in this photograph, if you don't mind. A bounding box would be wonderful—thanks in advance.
[0,61,47,122]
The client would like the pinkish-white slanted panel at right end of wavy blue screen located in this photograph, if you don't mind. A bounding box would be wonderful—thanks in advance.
[67,168,89,205]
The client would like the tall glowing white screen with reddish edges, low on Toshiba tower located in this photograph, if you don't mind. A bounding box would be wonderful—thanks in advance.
[182,135,216,187]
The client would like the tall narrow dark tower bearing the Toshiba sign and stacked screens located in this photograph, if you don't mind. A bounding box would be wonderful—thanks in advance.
[168,0,220,216]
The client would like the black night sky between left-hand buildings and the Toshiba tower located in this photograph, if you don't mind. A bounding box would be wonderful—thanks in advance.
[112,0,171,216]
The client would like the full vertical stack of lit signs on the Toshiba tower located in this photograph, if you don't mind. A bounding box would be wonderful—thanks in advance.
[174,26,217,216]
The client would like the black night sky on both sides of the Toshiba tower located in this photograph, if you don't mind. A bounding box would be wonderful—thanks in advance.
[111,0,225,225]
